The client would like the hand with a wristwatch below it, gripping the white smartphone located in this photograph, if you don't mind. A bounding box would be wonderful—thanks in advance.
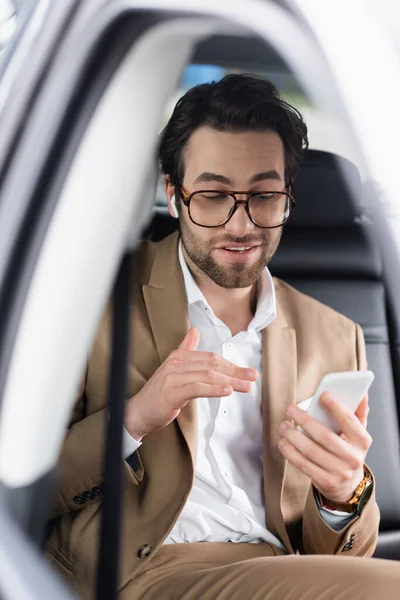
[278,393,372,504]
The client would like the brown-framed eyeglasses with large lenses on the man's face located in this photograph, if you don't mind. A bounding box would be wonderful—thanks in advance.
[180,190,296,229]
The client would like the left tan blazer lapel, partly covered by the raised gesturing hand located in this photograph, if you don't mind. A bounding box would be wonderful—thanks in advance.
[142,234,197,465]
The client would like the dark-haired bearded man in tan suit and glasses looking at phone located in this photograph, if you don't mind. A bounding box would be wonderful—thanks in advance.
[47,75,400,600]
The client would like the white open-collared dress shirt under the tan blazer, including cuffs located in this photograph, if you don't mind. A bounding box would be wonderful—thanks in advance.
[123,243,354,550]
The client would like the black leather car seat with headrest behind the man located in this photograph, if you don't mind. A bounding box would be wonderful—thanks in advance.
[147,150,400,560]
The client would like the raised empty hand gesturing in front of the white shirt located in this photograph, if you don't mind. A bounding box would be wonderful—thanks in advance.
[125,327,257,442]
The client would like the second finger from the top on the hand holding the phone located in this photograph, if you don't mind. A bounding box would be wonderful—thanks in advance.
[286,404,363,469]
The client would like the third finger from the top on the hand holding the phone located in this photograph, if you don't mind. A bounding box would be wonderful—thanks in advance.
[279,421,347,473]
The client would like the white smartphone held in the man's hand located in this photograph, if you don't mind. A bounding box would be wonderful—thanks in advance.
[298,371,375,433]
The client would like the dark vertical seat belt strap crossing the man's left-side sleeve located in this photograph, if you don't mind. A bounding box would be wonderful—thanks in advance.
[96,254,132,600]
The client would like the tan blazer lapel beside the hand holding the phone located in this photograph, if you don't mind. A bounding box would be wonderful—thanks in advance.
[262,292,297,552]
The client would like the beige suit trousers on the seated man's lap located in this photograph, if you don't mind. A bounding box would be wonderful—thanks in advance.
[119,542,400,600]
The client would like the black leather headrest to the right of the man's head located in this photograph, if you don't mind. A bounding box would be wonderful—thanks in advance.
[271,150,382,279]
